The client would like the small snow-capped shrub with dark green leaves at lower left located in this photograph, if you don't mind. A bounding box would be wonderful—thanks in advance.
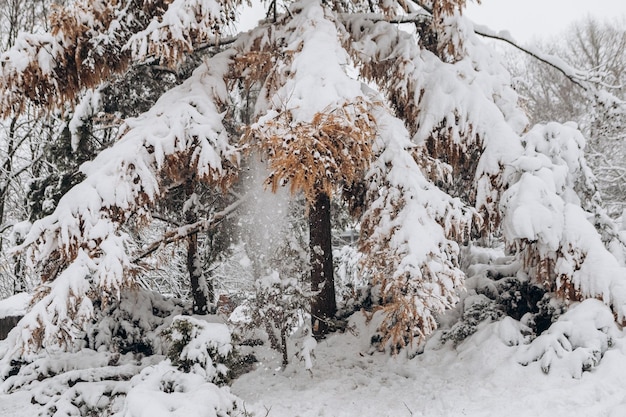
[164,316,233,384]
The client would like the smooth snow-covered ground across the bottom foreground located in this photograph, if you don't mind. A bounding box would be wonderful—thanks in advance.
[0,313,626,417]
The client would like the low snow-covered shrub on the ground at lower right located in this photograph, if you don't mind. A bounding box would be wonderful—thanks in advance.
[518,299,618,378]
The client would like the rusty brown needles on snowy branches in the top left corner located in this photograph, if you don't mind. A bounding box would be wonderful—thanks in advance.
[0,0,240,116]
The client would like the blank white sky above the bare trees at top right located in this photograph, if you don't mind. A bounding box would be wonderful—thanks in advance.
[465,0,626,42]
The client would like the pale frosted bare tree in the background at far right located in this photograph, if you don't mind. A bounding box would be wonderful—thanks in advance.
[509,16,626,217]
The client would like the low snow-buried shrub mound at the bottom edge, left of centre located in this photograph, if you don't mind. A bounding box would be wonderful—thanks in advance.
[119,362,241,417]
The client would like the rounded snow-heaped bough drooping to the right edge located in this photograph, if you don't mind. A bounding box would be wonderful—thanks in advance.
[501,123,626,321]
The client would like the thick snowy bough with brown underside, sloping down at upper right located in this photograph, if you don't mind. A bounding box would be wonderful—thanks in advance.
[347,15,528,208]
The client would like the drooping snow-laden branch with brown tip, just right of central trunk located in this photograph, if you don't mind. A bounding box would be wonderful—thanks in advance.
[360,105,474,350]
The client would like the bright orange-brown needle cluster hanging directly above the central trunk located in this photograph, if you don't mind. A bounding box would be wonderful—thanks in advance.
[245,102,375,201]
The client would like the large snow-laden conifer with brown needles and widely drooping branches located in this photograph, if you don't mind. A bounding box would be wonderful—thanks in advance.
[0,0,626,376]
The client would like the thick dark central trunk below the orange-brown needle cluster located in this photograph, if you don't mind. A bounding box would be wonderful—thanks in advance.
[309,193,337,339]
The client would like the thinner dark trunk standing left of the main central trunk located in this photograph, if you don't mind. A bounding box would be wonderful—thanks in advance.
[185,181,208,314]
